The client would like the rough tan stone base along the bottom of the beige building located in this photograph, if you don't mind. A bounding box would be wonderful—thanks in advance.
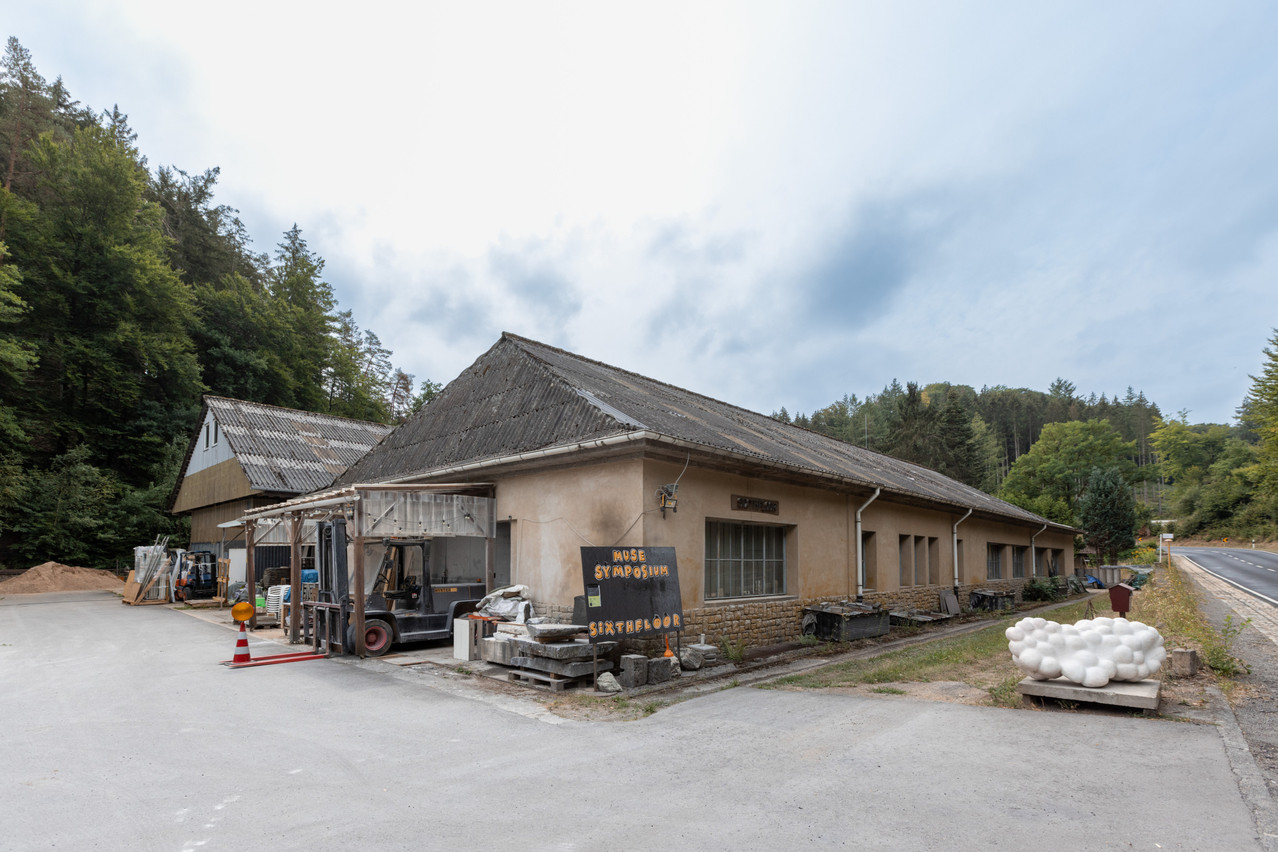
[533,579,1026,654]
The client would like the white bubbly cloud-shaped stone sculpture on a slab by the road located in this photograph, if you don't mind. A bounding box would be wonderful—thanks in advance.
[1005,618,1167,686]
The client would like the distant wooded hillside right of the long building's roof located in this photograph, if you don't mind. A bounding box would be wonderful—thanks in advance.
[772,344,1278,549]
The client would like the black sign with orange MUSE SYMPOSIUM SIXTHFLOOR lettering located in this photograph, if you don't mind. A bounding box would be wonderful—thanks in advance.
[581,547,684,643]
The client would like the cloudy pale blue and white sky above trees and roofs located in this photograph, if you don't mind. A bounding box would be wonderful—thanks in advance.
[9,0,1278,423]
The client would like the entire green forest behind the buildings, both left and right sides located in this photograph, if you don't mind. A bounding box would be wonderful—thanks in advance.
[0,38,1278,567]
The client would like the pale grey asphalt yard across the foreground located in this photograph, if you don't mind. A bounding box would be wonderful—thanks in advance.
[0,593,1265,852]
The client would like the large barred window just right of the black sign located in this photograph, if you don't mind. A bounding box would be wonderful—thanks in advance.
[705,521,786,600]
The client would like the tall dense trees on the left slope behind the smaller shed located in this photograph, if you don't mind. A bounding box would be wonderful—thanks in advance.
[0,37,437,567]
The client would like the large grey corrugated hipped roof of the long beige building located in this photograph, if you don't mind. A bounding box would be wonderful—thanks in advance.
[339,333,1067,529]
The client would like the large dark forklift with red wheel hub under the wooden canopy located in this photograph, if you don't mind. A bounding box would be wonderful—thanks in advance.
[305,519,487,657]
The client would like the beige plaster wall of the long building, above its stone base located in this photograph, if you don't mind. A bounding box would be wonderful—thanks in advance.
[497,457,1074,632]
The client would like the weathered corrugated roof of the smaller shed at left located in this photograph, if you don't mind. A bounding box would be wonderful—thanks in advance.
[204,396,391,494]
